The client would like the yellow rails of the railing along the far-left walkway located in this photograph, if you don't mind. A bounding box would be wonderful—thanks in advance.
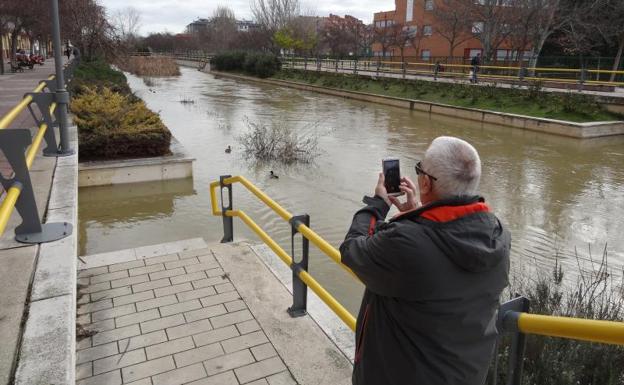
[0,75,56,236]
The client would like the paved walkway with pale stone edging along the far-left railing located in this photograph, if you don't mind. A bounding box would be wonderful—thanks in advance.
[0,60,78,384]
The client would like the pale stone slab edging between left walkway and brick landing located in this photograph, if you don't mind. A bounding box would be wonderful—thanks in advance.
[15,126,78,385]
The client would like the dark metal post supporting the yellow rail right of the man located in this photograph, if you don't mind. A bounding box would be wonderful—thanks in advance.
[494,297,530,385]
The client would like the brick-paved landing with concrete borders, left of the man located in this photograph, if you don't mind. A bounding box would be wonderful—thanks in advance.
[76,239,351,385]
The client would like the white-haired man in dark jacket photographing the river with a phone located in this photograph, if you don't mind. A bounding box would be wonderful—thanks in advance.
[340,137,511,385]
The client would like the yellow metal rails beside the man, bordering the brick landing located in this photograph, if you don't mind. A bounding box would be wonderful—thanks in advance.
[210,176,624,345]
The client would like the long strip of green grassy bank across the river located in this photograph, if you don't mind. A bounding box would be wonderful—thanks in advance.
[272,70,624,122]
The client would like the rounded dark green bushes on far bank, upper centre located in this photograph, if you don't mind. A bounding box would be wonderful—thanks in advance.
[210,51,282,78]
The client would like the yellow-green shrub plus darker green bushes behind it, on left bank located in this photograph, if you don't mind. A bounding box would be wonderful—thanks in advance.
[69,61,171,161]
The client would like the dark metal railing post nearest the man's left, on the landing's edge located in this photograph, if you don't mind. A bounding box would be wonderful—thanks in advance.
[288,214,310,318]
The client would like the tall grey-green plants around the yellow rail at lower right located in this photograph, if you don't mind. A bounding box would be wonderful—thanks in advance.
[498,247,624,385]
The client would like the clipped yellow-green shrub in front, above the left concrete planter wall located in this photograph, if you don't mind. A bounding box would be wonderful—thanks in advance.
[70,87,171,160]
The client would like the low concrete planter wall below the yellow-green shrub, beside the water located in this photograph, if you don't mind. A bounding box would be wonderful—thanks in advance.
[78,139,195,187]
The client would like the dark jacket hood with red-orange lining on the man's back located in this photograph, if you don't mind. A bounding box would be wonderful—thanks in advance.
[397,196,511,272]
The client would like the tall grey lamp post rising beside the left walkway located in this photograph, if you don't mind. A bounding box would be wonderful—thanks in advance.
[50,0,74,155]
